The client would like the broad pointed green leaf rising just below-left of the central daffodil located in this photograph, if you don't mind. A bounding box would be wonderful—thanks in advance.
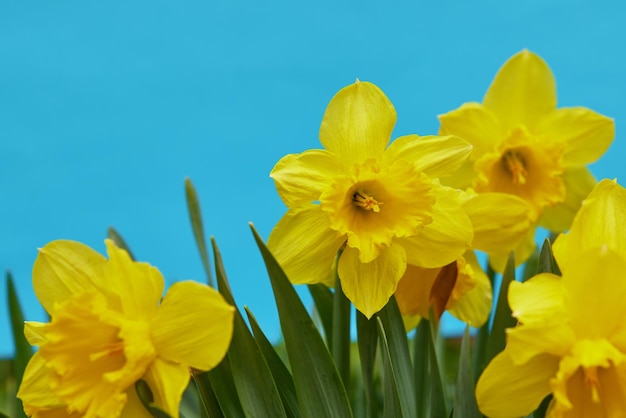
[250,225,352,418]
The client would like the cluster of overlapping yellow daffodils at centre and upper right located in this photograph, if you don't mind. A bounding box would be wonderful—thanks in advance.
[268,51,614,328]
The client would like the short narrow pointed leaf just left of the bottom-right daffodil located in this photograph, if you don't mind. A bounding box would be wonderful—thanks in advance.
[452,327,481,418]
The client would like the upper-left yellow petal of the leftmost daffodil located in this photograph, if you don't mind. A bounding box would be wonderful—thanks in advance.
[33,240,106,314]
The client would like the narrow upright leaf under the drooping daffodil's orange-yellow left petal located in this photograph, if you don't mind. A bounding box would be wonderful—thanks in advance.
[413,319,430,418]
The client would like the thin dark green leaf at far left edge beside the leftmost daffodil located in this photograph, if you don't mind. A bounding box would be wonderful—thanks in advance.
[7,271,33,417]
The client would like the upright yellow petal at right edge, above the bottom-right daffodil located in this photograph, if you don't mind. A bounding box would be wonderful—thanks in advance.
[552,179,626,271]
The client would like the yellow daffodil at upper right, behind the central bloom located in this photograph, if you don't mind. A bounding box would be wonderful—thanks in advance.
[439,50,615,269]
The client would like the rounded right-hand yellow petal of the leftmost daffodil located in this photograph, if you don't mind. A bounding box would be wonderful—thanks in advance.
[150,281,234,370]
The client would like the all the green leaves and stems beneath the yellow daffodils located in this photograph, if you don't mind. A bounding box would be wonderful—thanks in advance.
[0,180,572,418]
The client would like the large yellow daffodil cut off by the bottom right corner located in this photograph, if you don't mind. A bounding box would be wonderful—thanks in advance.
[476,246,626,418]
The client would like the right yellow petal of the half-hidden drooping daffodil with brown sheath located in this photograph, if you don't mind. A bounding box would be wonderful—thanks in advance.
[448,251,493,328]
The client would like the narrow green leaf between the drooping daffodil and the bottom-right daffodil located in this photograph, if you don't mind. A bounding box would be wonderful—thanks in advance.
[485,253,517,363]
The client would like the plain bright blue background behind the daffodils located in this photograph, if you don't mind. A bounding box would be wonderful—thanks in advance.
[0,0,626,356]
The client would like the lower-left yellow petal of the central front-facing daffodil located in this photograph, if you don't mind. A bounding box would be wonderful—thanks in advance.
[267,204,346,284]
